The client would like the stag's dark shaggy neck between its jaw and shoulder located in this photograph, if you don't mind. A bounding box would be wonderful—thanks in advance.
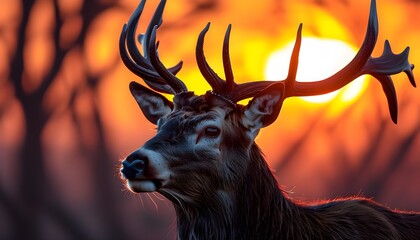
[174,145,299,239]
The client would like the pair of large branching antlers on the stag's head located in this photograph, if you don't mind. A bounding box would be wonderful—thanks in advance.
[120,0,416,123]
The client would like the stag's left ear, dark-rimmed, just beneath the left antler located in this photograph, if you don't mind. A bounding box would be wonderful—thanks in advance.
[130,82,173,124]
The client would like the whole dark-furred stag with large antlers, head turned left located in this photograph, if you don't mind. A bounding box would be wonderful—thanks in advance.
[120,0,420,240]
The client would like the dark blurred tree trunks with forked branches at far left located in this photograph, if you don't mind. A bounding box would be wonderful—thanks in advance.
[6,0,124,239]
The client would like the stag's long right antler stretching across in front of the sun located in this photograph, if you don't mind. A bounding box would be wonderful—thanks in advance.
[196,0,416,123]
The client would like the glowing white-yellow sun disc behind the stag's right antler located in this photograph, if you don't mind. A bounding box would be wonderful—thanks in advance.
[265,37,367,103]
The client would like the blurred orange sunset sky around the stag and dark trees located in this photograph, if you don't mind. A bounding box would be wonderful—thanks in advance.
[0,0,420,239]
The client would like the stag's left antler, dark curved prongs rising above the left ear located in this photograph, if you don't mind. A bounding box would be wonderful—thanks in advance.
[119,0,188,94]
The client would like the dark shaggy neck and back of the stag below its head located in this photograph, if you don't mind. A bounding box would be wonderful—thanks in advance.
[169,142,420,240]
